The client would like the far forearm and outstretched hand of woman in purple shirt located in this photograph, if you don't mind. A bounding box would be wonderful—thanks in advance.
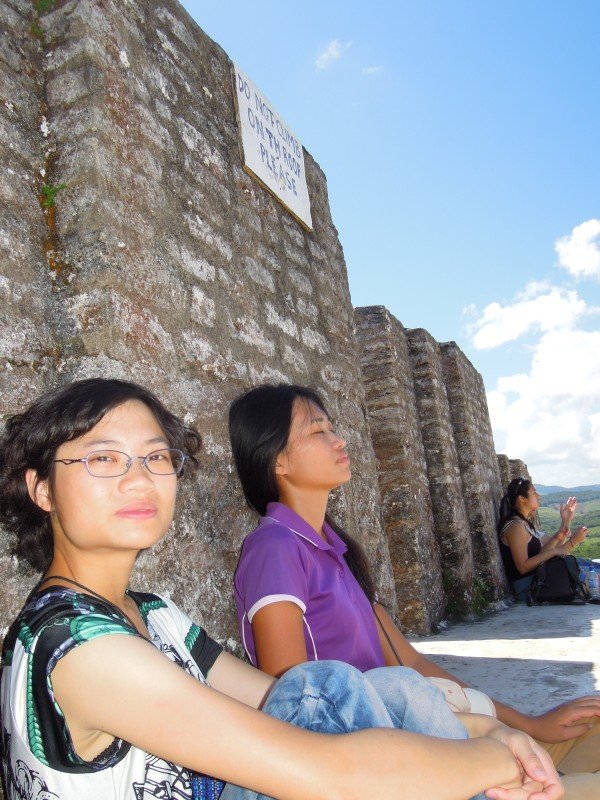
[375,604,600,742]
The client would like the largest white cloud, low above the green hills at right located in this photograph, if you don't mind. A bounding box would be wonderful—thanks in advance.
[488,330,600,486]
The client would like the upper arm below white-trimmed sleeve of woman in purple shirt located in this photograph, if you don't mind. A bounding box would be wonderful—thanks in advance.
[252,600,308,677]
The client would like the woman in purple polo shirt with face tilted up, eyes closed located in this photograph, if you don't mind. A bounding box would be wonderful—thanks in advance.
[229,384,600,788]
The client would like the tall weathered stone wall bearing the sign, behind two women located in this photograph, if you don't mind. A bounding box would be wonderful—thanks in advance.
[0,0,395,647]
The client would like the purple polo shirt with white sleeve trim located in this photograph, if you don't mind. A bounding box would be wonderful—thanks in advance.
[234,503,385,672]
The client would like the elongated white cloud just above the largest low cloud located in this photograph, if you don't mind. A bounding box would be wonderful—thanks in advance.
[467,282,592,350]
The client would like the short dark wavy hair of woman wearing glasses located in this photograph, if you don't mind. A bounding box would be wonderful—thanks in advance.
[0,378,202,571]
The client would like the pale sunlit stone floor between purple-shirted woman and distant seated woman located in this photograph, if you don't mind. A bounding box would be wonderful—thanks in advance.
[411,603,600,714]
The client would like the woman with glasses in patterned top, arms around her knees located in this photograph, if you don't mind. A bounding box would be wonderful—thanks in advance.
[0,379,562,800]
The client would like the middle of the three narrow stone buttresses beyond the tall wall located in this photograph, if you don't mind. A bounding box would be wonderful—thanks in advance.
[407,328,473,616]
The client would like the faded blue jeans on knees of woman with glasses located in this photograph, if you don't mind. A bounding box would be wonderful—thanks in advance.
[220,661,485,800]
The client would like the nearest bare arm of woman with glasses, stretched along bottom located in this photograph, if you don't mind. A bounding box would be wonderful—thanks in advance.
[52,635,524,800]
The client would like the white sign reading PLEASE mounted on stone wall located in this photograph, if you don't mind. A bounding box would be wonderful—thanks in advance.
[233,64,312,230]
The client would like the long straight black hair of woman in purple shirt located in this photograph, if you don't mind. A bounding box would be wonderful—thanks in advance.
[229,383,375,603]
